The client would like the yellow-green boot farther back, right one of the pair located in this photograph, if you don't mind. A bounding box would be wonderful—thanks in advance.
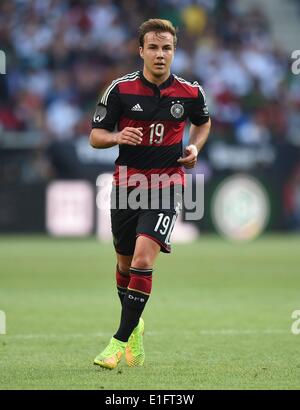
[125,318,145,367]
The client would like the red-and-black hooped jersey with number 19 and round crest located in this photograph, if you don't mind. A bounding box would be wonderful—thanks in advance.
[92,71,209,187]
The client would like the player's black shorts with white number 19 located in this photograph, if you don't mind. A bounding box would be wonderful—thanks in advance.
[111,186,183,255]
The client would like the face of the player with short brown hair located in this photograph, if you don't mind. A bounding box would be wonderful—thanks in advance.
[140,31,175,80]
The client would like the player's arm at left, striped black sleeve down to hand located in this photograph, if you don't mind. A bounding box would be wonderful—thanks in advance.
[90,82,143,148]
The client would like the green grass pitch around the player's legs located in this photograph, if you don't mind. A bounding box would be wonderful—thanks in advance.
[0,236,300,390]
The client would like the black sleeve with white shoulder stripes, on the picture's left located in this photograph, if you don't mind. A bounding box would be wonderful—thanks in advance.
[92,84,122,131]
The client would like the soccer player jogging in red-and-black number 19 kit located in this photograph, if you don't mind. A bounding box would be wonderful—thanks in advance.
[90,19,210,369]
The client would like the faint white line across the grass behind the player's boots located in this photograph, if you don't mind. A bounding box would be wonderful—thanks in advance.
[0,329,290,340]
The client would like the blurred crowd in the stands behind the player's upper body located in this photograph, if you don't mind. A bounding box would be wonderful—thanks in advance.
[0,0,300,231]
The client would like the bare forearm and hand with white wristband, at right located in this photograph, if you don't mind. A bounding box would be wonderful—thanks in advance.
[177,118,211,168]
